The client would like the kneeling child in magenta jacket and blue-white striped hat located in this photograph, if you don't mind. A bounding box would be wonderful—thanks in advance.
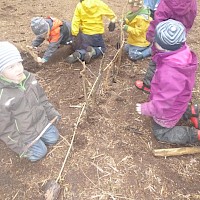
[136,19,200,144]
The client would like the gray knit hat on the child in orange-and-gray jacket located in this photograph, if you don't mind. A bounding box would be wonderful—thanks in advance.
[31,17,49,35]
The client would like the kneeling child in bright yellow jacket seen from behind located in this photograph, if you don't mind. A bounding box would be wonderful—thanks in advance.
[66,0,116,64]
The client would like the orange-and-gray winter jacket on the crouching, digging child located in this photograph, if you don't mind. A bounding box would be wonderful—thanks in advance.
[32,17,72,61]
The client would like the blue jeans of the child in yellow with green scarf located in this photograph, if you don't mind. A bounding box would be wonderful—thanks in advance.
[124,44,151,61]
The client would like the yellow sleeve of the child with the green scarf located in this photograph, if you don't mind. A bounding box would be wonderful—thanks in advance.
[124,18,147,37]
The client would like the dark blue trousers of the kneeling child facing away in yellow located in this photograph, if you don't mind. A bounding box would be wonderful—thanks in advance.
[74,32,106,60]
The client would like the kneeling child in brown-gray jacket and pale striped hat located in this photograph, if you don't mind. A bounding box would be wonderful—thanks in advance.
[0,42,60,161]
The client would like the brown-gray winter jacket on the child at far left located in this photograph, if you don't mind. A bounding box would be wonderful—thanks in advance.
[0,71,59,154]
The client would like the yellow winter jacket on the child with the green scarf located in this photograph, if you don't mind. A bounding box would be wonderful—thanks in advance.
[124,8,152,47]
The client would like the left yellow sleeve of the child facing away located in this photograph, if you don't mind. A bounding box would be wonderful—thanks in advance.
[72,3,81,36]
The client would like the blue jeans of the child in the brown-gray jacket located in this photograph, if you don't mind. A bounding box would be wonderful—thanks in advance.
[27,125,59,162]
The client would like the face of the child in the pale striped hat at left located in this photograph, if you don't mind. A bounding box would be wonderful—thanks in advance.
[1,62,25,83]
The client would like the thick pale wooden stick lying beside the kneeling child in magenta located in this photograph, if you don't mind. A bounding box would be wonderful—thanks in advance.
[152,147,200,157]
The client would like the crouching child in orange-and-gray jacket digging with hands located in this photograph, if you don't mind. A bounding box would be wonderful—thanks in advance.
[31,17,72,63]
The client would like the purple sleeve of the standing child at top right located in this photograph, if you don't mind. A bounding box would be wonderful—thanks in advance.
[146,1,171,43]
